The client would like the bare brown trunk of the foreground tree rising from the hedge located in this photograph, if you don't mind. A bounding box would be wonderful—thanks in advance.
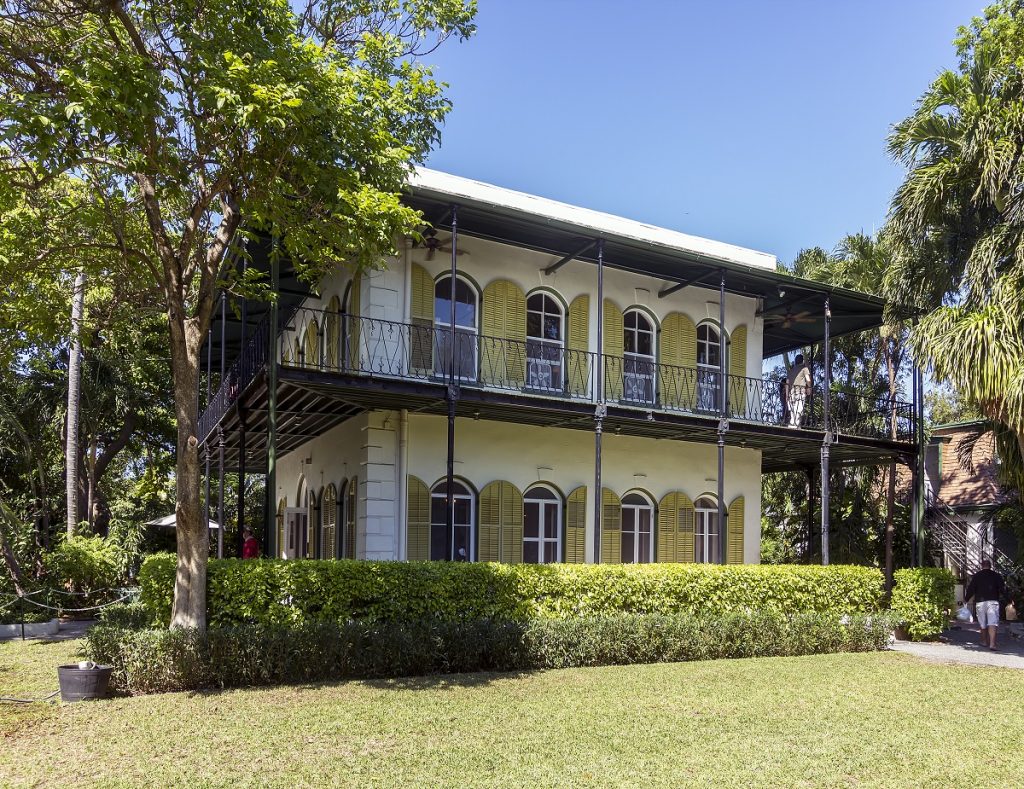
[169,307,210,630]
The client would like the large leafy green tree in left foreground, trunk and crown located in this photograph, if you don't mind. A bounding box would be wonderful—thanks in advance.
[0,0,475,628]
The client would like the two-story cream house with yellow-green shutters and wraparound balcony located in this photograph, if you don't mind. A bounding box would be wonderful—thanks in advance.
[200,170,916,563]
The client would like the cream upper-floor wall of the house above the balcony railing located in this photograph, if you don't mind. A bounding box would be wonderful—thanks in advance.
[280,235,763,378]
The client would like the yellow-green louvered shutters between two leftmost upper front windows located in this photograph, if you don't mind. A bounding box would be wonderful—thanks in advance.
[480,279,526,389]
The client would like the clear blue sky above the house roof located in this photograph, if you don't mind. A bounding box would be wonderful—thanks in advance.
[427,0,985,262]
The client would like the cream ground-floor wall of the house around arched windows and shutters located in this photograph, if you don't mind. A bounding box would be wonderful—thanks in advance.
[278,411,761,564]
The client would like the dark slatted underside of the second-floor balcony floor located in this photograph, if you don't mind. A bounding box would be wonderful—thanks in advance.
[208,366,915,474]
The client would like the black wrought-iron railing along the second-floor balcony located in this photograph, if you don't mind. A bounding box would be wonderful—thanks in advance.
[200,308,914,442]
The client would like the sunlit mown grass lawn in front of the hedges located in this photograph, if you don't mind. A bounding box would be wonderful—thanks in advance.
[0,642,1024,788]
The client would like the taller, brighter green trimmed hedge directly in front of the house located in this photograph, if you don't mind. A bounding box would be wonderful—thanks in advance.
[139,555,883,627]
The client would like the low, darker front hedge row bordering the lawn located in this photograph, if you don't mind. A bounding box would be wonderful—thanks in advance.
[86,613,891,694]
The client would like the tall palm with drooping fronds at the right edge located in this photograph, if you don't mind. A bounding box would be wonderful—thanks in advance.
[884,0,1024,488]
